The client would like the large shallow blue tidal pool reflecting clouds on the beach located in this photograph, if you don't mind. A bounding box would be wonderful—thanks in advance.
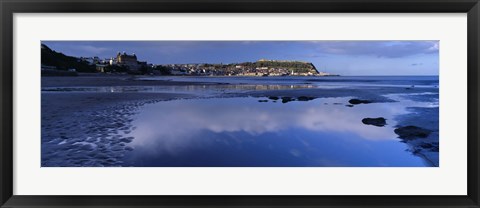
[124,96,438,167]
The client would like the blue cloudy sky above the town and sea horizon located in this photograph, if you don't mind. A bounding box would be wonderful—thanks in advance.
[42,40,439,75]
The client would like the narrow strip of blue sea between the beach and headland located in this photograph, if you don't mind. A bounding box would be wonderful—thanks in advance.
[42,76,439,94]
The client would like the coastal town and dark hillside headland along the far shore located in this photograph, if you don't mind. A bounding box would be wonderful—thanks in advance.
[41,44,338,76]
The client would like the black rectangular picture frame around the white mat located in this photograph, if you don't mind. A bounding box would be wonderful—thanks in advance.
[0,0,480,207]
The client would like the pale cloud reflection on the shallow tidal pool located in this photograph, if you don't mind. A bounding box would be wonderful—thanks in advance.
[131,95,436,155]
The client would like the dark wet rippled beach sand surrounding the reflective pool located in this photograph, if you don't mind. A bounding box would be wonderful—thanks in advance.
[41,76,439,167]
